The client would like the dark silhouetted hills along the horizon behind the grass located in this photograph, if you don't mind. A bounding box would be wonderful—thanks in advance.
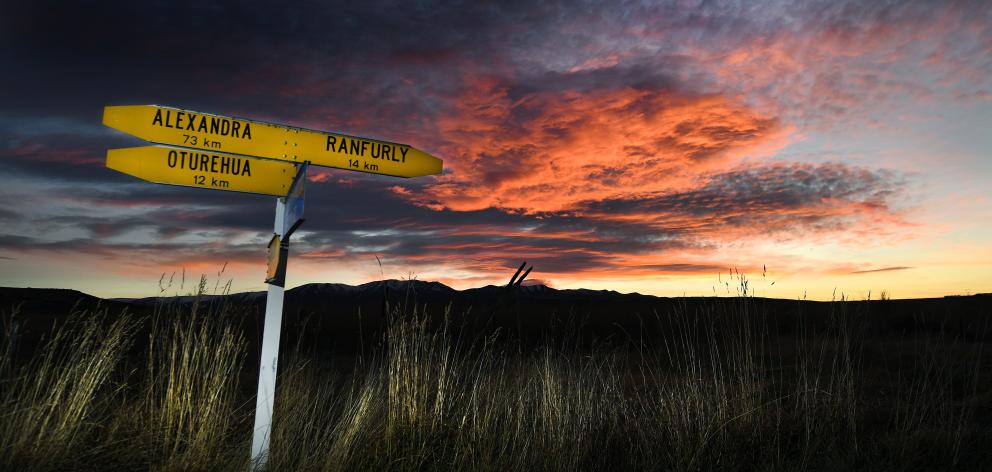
[0,280,992,358]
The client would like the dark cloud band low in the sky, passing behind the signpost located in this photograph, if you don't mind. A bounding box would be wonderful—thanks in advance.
[0,160,696,273]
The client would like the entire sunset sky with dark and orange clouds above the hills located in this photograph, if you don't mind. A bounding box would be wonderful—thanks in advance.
[0,0,992,300]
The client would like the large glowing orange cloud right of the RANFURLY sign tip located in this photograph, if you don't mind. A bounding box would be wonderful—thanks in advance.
[412,77,785,214]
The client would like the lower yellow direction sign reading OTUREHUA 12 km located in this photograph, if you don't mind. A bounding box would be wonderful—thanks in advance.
[107,146,296,197]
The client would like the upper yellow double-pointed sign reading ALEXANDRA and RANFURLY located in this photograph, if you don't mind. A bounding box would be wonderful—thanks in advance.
[103,105,442,177]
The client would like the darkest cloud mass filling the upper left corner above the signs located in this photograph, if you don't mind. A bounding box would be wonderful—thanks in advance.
[0,1,539,119]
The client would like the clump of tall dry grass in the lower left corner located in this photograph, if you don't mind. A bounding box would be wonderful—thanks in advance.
[0,310,135,470]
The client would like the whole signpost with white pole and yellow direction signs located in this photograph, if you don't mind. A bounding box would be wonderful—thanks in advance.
[103,105,442,469]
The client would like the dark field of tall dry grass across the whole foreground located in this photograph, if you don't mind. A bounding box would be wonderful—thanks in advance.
[0,283,992,471]
